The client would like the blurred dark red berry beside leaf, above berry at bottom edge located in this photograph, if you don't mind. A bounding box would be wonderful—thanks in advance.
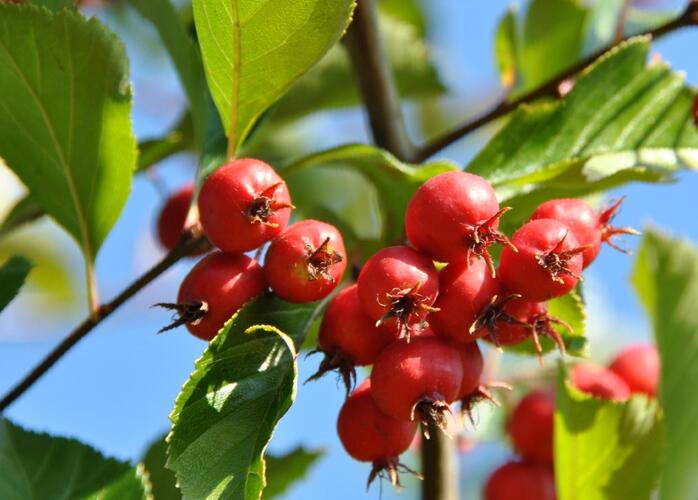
[507,390,555,464]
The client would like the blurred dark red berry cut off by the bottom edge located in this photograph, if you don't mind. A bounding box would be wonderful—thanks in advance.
[484,461,556,500]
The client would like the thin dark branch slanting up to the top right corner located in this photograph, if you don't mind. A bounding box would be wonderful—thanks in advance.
[413,0,698,162]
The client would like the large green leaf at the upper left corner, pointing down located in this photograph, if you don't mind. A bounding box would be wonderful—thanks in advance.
[0,4,136,260]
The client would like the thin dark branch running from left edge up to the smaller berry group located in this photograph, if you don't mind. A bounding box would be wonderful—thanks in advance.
[0,232,205,413]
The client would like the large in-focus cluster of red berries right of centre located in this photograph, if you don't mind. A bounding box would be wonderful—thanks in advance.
[320,172,634,488]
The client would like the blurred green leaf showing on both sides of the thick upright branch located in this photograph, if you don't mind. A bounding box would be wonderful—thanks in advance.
[270,16,444,125]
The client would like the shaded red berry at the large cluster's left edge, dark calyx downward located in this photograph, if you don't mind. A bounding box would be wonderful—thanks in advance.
[309,285,397,391]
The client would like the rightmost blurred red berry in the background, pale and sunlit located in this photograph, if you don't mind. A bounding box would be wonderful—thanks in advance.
[609,344,659,397]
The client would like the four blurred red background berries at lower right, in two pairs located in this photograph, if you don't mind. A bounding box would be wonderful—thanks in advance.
[484,344,659,500]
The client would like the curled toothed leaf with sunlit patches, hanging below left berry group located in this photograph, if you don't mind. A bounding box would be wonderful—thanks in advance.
[167,295,318,500]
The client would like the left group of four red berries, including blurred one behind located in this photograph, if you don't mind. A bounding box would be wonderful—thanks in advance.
[158,159,346,340]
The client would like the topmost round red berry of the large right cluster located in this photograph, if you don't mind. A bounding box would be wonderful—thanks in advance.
[405,172,509,267]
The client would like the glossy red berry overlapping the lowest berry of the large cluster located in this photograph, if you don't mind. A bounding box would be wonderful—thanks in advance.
[371,337,463,429]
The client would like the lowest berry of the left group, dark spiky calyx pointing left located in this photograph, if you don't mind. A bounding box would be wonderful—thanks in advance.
[156,252,267,340]
